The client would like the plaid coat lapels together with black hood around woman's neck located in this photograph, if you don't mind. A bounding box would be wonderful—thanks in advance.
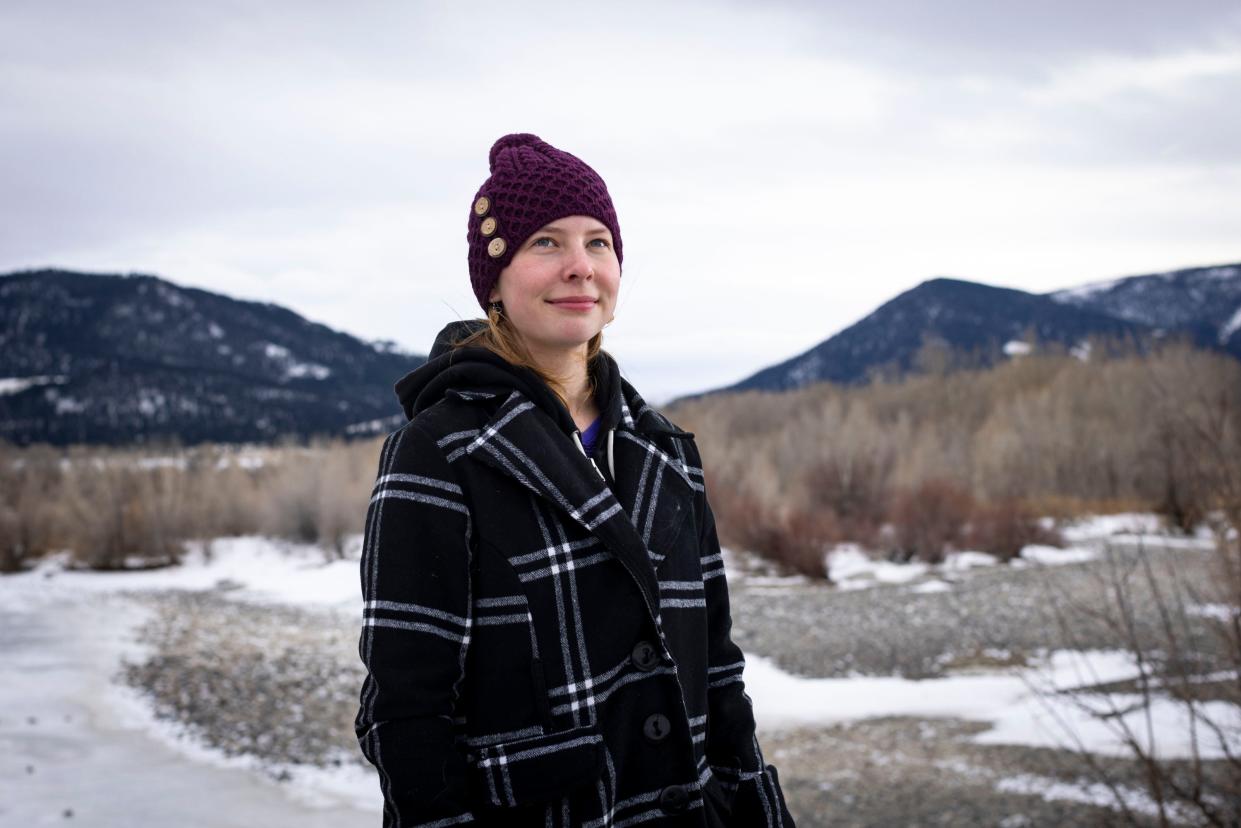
[395,320,702,626]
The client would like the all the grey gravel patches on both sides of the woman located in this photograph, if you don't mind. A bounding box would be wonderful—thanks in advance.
[120,549,1231,826]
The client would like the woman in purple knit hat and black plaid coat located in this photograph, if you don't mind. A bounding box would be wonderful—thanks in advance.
[356,134,793,828]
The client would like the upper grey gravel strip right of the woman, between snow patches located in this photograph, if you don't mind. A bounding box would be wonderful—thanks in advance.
[731,544,1215,679]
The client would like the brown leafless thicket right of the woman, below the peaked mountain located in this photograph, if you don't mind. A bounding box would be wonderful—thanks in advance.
[668,341,1241,576]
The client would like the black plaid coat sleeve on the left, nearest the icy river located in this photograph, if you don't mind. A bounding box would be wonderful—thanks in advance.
[354,422,474,828]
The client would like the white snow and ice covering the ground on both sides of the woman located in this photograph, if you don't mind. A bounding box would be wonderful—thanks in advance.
[0,515,1241,827]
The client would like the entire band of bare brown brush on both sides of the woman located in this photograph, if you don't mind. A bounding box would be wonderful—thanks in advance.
[0,343,1241,577]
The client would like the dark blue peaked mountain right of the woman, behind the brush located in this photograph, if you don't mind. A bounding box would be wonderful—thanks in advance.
[719,264,1241,391]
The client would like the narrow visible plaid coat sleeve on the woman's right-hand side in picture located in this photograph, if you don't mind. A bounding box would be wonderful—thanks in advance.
[691,439,793,828]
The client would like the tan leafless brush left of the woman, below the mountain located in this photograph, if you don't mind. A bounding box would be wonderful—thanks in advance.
[0,439,382,571]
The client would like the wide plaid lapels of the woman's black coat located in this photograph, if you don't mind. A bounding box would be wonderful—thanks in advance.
[463,377,701,627]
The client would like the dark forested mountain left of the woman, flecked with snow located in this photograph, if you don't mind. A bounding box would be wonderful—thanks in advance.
[0,269,426,444]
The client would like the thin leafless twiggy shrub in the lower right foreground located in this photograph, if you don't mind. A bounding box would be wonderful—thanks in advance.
[1039,545,1241,826]
